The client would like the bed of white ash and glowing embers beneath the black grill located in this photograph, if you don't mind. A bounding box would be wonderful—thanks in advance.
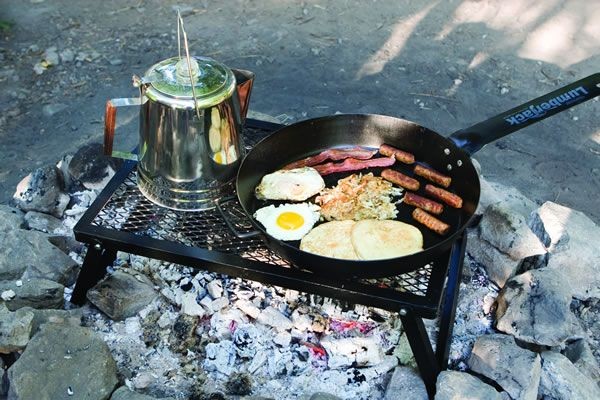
[79,254,408,399]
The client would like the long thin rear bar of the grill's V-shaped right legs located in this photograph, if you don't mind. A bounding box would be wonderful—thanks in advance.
[435,235,467,370]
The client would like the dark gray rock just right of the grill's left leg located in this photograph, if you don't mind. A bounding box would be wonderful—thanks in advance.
[87,270,158,321]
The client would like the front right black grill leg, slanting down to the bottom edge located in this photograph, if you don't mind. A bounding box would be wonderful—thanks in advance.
[400,309,440,399]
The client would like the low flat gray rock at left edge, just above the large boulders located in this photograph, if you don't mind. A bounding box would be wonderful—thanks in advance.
[0,278,65,311]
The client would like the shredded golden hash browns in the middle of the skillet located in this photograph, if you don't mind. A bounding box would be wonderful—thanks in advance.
[315,173,402,221]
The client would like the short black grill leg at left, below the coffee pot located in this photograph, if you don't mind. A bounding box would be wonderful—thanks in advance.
[71,245,117,305]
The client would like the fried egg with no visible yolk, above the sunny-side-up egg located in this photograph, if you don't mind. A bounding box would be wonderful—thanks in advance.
[255,167,325,201]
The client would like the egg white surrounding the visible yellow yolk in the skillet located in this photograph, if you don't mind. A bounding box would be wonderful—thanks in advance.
[254,203,320,240]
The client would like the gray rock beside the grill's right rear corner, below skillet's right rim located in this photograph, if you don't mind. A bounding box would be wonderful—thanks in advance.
[466,230,521,287]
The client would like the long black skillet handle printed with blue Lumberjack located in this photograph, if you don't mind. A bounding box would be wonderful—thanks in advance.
[448,73,600,154]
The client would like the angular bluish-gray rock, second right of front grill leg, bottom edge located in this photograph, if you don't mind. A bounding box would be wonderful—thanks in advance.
[468,334,541,400]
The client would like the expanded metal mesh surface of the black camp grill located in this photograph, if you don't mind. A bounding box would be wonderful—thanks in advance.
[91,124,433,296]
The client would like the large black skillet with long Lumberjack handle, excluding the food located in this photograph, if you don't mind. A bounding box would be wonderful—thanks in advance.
[221,73,600,278]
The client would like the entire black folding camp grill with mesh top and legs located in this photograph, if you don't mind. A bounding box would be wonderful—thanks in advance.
[71,120,466,397]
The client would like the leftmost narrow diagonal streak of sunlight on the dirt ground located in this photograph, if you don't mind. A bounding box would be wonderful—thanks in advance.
[355,2,438,80]
